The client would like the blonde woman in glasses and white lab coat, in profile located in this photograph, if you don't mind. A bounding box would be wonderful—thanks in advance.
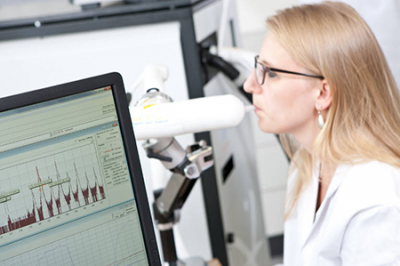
[245,2,400,266]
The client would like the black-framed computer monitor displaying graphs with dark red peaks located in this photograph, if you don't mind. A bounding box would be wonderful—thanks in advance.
[0,73,161,266]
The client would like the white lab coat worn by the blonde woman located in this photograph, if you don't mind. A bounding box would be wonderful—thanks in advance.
[283,161,400,266]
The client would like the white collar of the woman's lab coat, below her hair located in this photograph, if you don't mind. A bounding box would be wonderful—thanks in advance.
[299,164,350,248]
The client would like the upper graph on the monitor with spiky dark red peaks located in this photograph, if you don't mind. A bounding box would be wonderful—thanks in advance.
[0,141,107,235]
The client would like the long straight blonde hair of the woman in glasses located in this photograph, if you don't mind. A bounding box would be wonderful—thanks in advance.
[267,2,400,218]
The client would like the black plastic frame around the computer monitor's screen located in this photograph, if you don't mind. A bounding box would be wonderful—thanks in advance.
[0,72,161,266]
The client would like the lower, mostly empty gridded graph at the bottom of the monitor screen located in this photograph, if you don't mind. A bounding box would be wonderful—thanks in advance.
[2,206,148,266]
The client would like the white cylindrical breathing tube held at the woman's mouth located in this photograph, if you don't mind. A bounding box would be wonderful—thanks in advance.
[130,95,254,140]
